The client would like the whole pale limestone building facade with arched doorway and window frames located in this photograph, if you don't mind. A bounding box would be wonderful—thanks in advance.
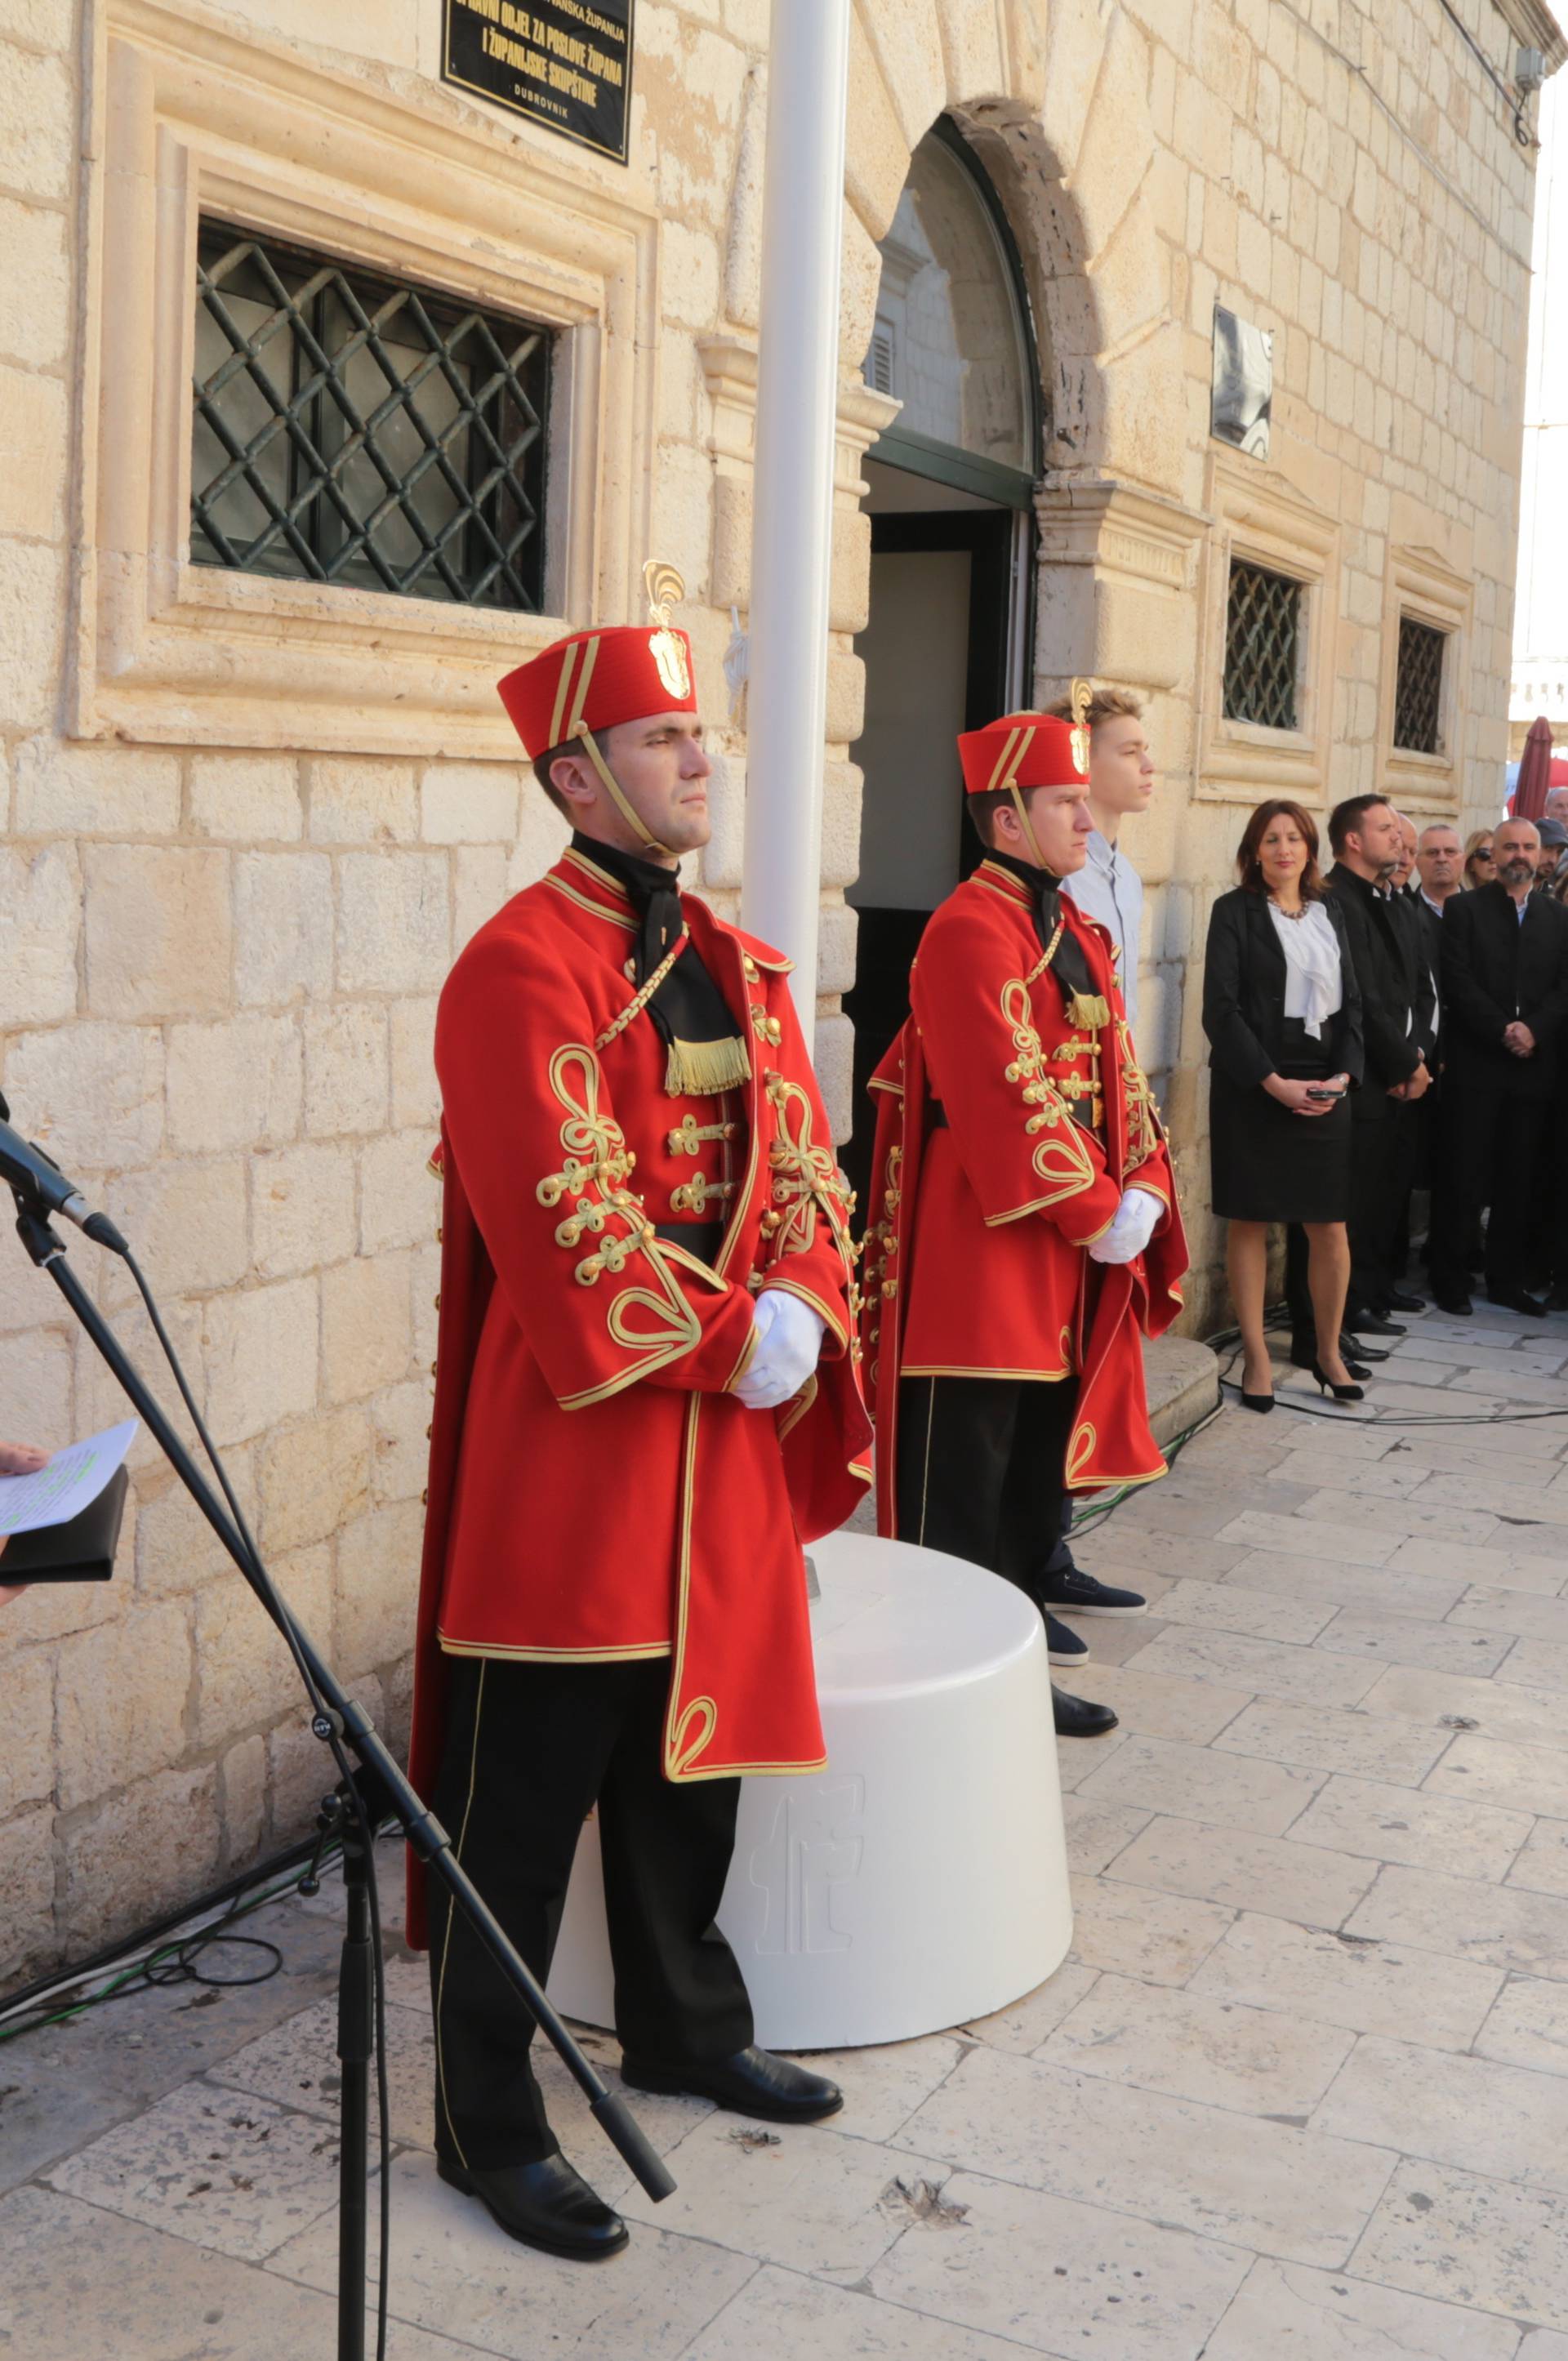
[0,0,1561,1979]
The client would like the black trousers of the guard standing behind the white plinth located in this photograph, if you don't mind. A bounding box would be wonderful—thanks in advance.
[898,1376,1077,1606]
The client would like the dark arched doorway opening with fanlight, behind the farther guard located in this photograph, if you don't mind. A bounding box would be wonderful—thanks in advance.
[845,118,1046,1187]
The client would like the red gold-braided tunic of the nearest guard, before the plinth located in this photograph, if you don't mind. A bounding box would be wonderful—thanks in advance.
[413,850,871,1936]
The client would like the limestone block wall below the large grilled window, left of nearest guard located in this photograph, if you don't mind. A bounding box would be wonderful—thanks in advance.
[0,734,562,1967]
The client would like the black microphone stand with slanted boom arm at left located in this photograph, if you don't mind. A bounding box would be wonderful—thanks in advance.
[11,1187,675,2361]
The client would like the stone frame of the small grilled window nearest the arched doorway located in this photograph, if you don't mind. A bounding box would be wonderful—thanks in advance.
[1195,448,1339,808]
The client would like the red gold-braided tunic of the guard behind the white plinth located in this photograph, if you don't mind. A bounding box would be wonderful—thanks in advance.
[862,862,1186,1532]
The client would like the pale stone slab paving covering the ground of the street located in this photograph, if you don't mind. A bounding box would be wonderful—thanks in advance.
[15,1306,1568,2361]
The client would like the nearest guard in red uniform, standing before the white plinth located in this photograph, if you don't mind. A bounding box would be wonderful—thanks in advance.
[411,567,871,2257]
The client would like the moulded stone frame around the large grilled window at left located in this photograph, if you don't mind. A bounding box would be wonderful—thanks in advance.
[69,0,659,760]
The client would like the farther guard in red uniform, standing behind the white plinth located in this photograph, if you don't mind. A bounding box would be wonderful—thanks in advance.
[862,682,1186,1735]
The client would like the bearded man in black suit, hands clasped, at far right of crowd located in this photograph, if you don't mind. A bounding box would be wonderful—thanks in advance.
[1431,819,1568,1317]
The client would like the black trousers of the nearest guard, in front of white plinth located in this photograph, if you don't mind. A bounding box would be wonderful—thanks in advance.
[430,1657,751,2170]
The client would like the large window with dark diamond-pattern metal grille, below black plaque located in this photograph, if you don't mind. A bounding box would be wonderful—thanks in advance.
[191,222,550,614]
